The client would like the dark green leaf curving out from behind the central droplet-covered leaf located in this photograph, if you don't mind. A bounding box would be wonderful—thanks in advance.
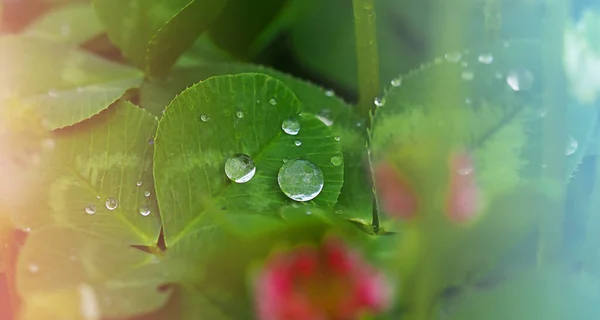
[140,63,372,224]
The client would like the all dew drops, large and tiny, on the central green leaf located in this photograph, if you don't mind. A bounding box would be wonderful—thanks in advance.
[219,98,342,202]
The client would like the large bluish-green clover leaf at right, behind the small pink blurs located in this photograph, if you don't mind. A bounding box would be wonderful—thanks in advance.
[371,41,597,316]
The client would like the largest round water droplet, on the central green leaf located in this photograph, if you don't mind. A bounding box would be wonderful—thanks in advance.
[277,159,324,201]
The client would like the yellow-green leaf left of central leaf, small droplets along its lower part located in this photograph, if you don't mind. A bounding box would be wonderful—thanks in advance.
[13,102,160,245]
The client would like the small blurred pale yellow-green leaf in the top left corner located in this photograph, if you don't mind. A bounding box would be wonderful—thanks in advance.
[23,2,104,45]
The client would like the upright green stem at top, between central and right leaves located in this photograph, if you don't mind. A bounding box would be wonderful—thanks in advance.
[352,0,380,125]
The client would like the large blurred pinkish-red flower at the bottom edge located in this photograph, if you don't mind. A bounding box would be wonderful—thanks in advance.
[255,239,391,320]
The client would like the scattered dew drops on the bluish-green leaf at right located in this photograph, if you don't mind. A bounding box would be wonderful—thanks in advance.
[380,42,579,159]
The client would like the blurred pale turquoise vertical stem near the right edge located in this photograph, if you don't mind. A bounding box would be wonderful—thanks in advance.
[538,0,570,266]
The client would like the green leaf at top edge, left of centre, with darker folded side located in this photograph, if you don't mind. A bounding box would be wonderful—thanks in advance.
[94,0,228,75]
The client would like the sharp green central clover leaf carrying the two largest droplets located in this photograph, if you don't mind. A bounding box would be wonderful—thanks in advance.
[154,74,343,256]
